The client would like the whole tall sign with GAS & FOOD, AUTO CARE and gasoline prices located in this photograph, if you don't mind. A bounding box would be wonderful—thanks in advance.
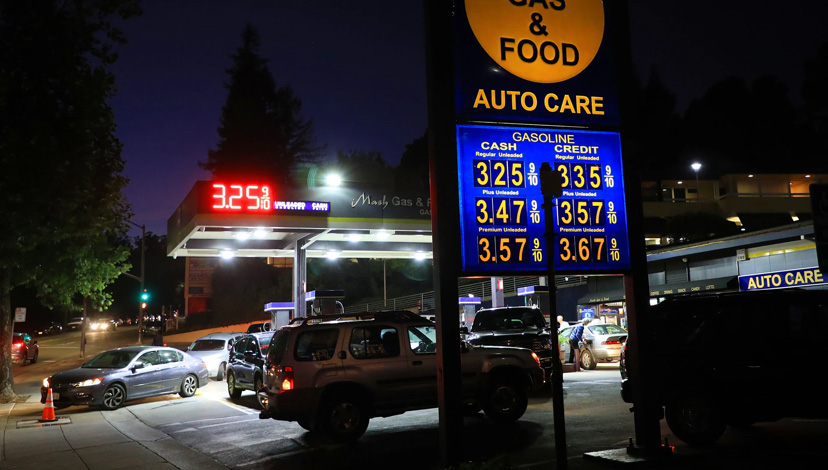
[453,0,630,275]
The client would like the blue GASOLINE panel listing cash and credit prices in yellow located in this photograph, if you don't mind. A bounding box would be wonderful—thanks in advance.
[457,125,630,274]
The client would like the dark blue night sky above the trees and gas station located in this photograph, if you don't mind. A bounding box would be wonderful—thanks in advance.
[111,0,828,235]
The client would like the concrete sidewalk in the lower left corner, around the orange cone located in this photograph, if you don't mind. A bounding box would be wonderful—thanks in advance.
[0,387,227,470]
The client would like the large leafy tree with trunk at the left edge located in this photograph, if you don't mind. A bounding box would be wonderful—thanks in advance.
[0,0,140,399]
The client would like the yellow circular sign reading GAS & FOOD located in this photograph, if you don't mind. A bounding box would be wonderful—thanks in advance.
[465,0,604,83]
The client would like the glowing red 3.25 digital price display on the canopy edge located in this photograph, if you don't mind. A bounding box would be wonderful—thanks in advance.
[209,183,331,214]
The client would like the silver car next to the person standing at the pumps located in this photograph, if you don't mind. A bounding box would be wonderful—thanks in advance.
[558,322,628,370]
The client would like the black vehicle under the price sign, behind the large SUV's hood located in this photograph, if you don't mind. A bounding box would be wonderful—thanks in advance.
[461,307,555,381]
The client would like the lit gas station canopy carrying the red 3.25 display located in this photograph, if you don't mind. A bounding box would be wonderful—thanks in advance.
[167,181,432,259]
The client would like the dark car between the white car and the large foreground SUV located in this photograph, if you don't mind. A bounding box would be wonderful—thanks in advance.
[227,332,273,405]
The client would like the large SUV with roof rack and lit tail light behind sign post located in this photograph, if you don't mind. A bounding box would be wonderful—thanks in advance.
[259,311,544,441]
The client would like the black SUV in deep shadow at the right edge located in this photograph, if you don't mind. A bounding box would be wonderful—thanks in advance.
[621,290,828,445]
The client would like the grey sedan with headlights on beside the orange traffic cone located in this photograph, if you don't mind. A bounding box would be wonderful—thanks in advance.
[40,346,209,410]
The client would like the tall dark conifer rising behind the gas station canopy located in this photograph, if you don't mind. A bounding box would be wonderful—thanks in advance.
[200,24,320,183]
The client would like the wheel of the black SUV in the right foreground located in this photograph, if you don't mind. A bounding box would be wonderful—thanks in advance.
[665,395,725,446]
